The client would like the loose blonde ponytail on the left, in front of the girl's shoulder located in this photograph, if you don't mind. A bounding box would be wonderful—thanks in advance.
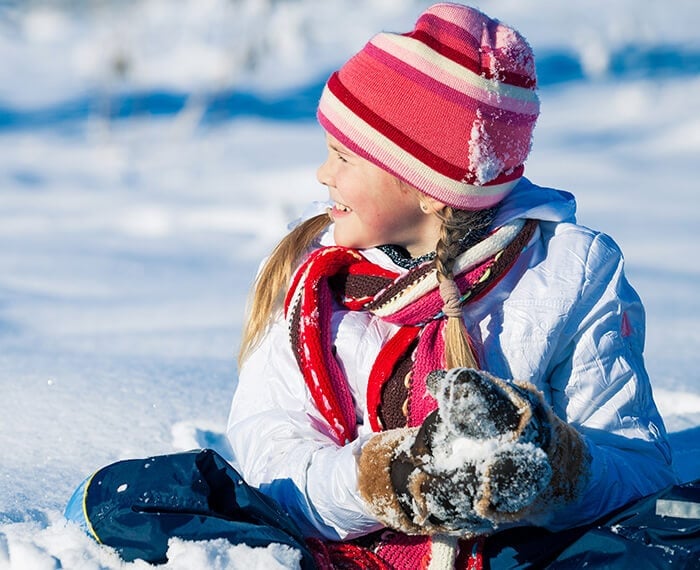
[238,214,331,366]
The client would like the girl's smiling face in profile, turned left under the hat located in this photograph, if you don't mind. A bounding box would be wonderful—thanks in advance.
[317,135,441,257]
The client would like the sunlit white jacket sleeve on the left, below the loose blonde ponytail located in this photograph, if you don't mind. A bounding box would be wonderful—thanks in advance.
[227,310,381,540]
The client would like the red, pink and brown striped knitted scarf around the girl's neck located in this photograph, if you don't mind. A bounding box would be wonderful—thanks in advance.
[285,220,537,445]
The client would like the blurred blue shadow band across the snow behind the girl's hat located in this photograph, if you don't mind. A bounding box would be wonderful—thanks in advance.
[0,45,700,132]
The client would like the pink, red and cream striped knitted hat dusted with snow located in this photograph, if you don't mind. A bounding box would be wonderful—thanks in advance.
[317,4,539,210]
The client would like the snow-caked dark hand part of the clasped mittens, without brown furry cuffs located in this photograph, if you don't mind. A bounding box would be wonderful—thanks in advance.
[391,368,552,529]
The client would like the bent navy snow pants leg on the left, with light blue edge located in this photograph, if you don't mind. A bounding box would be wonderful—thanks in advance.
[66,449,314,569]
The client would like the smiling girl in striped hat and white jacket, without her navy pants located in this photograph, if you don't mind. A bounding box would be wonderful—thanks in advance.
[228,4,673,568]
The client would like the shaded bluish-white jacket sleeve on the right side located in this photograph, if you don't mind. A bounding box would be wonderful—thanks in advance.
[545,226,675,530]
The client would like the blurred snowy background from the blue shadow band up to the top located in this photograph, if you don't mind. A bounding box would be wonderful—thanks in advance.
[0,0,700,125]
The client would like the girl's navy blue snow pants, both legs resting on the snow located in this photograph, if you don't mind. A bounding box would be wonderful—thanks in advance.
[66,449,700,570]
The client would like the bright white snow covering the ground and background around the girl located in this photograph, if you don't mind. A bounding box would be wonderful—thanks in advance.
[0,0,700,570]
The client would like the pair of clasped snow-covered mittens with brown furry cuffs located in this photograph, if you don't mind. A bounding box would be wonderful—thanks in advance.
[359,368,590,536]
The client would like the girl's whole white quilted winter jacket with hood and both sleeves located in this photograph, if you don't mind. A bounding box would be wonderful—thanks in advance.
[227,179,675,540]
